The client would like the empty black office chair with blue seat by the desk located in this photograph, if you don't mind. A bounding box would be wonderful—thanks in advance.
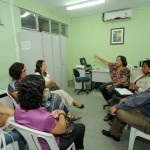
[73,69,90,95]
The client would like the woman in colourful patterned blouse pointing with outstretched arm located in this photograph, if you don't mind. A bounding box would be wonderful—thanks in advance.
[94,55,130,104]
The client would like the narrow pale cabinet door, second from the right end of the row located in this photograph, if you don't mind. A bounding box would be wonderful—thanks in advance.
[52,34,62,88]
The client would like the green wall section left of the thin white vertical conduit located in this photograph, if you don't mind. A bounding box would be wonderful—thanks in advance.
[0,1,17,88]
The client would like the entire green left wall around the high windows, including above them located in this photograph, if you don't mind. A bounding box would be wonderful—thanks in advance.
[0,0,70,89]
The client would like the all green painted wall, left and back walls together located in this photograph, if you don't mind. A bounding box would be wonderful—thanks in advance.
[0,0,150,88]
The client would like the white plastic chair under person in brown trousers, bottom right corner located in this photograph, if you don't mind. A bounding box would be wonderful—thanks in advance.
[128,127,150,150]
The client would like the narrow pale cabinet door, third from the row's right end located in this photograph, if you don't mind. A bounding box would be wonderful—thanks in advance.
[42,33,54,77]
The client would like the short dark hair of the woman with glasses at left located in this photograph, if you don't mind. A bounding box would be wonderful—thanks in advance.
[9,62,24,80]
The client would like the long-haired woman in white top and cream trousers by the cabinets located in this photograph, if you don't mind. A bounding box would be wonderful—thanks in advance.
[35,60,84,108]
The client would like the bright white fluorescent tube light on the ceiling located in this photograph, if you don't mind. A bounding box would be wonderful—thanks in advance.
[66,0,105,10]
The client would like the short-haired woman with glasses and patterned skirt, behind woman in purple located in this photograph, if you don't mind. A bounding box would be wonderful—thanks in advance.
[8,62,81,120]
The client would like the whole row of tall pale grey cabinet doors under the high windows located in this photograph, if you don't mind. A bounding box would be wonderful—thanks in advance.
[20,31,67,89]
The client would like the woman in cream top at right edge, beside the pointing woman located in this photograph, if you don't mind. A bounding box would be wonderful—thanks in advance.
[104,60,150,125]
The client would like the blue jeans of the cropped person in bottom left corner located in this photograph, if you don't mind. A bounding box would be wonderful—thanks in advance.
[4,130,26,150]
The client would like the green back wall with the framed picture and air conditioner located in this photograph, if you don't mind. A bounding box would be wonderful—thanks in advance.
[70,7,150,76]
